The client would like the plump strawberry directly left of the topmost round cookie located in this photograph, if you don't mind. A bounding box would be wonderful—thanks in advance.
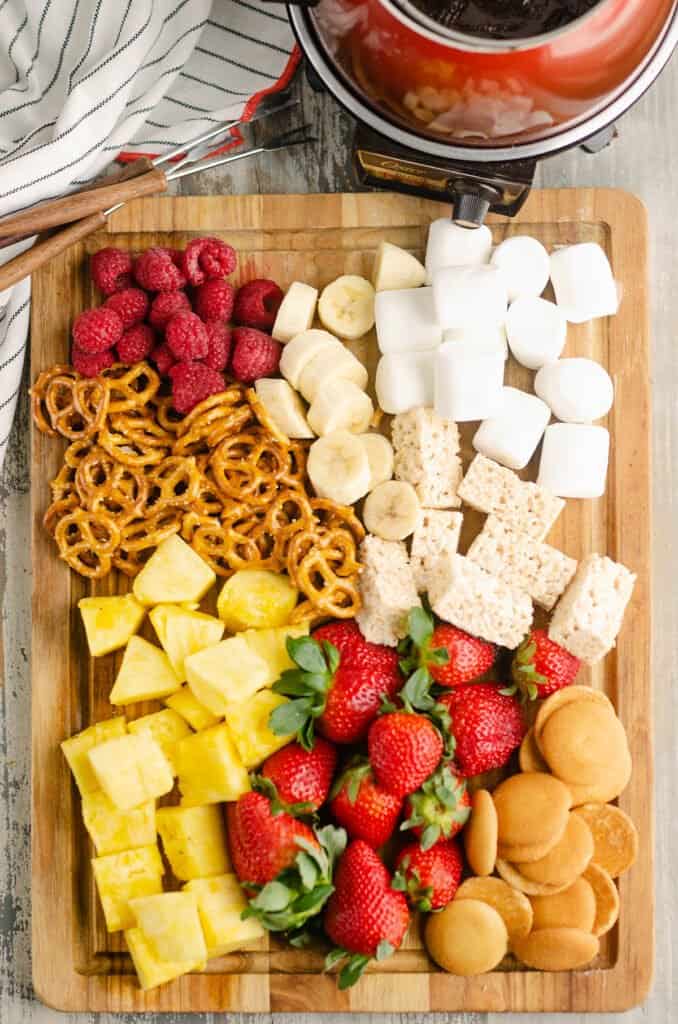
[438,683,526,777]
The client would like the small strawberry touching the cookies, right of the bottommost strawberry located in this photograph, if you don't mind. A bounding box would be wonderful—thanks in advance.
[393,840,464,912]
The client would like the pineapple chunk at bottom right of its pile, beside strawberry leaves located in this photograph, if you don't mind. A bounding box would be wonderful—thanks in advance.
[183,874,266,959]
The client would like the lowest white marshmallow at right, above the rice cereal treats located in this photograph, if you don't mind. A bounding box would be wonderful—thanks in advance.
[537,423,609,498]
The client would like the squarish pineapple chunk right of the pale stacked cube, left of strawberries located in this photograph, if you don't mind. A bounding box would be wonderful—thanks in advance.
[177,724,251,807]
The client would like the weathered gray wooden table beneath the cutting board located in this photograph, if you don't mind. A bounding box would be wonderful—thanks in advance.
[0,60,678,1024]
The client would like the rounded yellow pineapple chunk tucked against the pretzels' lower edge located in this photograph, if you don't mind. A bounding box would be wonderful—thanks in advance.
[216,569,299,633]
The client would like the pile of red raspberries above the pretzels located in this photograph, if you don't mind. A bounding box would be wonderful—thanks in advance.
[71,238,283,414]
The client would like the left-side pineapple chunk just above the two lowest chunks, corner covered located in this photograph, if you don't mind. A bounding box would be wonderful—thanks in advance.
[92,845,164,932]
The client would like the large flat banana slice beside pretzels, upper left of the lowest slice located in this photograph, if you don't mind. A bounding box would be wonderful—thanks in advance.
[306,430,370,505]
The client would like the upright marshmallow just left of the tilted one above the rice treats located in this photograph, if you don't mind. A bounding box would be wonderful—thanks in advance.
[433,341,504,423]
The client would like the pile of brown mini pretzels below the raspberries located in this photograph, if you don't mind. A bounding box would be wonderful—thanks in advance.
[31,362,365,622]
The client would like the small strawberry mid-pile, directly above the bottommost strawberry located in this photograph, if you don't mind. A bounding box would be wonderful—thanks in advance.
[329,757,402,849]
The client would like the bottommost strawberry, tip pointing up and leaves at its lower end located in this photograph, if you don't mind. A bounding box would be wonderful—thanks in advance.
[324,839,410,988]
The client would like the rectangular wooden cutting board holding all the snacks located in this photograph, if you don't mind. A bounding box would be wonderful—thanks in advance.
[32,189,653,1013]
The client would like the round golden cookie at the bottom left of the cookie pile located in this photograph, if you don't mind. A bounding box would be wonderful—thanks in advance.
[424,899,508,977]
